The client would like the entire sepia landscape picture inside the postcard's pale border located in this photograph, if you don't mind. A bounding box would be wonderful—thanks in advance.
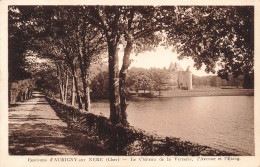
[1,1,256,167]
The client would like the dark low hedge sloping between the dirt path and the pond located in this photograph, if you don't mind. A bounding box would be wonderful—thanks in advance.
[44,98,234,156]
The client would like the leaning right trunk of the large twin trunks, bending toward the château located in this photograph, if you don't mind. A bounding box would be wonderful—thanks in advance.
[119,35,133,125]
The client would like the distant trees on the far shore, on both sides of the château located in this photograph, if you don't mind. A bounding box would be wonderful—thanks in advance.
[90,67,250,99]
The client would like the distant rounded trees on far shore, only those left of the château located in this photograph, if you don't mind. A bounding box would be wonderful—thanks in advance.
[90,68,170,98]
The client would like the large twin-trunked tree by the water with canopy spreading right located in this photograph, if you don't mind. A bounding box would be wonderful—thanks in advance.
[88,6,254,124]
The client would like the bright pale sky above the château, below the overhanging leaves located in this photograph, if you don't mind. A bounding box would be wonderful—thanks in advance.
[119,46,213,76]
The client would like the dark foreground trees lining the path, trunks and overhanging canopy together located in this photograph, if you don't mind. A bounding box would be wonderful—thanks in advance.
[9,6,254,125]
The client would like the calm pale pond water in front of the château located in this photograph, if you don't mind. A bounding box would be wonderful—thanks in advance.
[92,96,254,155]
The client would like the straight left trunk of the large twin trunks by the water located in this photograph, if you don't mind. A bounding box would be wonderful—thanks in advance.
[108,42,122,124]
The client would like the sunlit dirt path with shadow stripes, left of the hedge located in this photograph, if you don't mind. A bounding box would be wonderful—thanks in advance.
[8,92,78,155]
